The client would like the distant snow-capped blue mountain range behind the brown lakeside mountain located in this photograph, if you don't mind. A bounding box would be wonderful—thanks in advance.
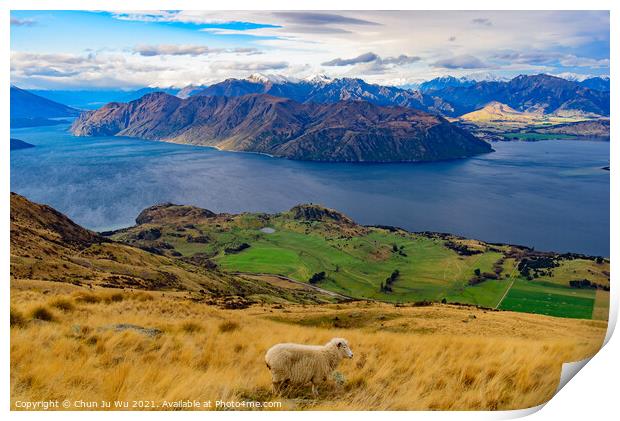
[185,74,610,117]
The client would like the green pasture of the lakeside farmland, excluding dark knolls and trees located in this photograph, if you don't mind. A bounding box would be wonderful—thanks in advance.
[109,206,609,318]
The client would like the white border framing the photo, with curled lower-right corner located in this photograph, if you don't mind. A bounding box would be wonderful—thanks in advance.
[0,0,620,421]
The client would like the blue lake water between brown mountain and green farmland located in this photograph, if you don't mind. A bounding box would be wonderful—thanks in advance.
[11,126,609,256]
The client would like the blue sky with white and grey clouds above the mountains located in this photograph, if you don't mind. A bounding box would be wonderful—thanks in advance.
[11,11,609,89]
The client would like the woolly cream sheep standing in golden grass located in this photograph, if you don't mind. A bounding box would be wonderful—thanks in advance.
[265,338,353,396]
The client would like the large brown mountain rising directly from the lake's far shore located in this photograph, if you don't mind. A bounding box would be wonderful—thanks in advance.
[71,91,492,162]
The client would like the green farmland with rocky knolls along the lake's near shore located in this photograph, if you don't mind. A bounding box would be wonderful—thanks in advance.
[110,205,609,318]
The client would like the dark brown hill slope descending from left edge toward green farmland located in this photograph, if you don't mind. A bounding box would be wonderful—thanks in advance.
[11,193,334,303]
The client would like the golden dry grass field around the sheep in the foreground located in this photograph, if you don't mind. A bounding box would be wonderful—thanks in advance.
[11,281,606,410]
